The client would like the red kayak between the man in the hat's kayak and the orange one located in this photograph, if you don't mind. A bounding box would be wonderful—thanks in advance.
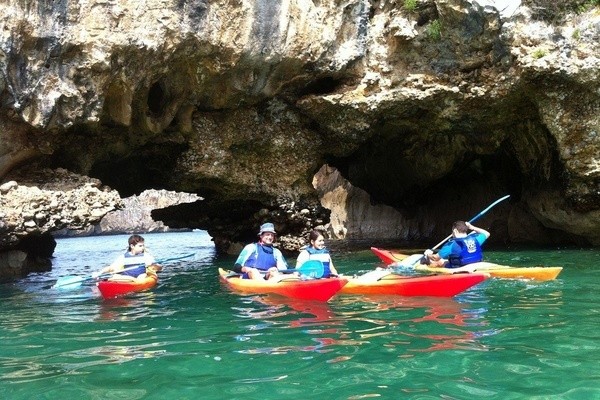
[340,271,487,297]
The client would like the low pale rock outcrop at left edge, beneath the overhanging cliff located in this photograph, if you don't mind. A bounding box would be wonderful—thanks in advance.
[0,168,122,282]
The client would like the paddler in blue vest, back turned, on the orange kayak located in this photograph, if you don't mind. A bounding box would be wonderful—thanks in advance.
[421,221,490,268]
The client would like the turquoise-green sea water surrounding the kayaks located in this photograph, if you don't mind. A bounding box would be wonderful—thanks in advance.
[0,232,600,400]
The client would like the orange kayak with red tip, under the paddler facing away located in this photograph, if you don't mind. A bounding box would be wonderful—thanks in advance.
[371,247,563,281]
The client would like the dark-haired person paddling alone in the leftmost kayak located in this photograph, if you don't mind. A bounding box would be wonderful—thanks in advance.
[92,235,162,281]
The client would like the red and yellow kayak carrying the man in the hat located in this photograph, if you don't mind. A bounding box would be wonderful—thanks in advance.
[219,268,348,301]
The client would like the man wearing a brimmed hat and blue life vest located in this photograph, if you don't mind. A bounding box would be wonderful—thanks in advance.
[233,222,287,279]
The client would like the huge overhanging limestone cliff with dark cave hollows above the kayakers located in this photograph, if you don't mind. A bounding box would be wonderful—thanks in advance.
[0,0,600,266]
